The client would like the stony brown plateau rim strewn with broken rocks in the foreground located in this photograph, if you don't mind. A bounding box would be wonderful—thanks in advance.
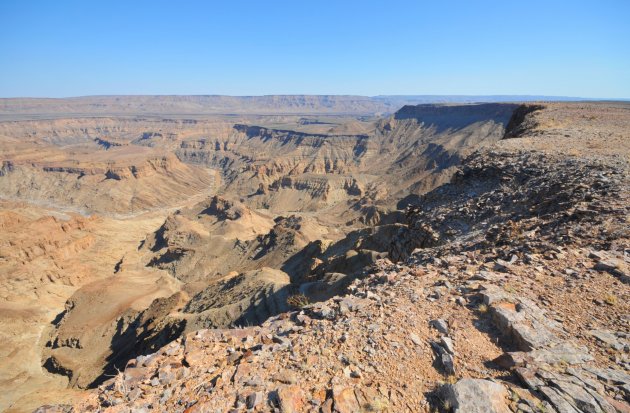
[39,104,630,413]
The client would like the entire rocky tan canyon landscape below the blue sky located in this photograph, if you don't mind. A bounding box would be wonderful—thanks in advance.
[0,97,630,413]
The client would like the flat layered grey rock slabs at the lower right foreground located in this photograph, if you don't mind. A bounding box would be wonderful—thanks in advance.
[482,286,630,413]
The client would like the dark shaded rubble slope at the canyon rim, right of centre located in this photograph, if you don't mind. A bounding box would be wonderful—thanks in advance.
[391,146,625,258]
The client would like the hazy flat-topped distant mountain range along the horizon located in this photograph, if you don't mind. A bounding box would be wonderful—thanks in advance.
[0,95,624,120]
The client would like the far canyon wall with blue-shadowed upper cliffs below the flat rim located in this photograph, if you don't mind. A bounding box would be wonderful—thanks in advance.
[177,104,518,211]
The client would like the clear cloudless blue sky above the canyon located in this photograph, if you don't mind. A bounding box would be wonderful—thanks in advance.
[0,0,630,98]
